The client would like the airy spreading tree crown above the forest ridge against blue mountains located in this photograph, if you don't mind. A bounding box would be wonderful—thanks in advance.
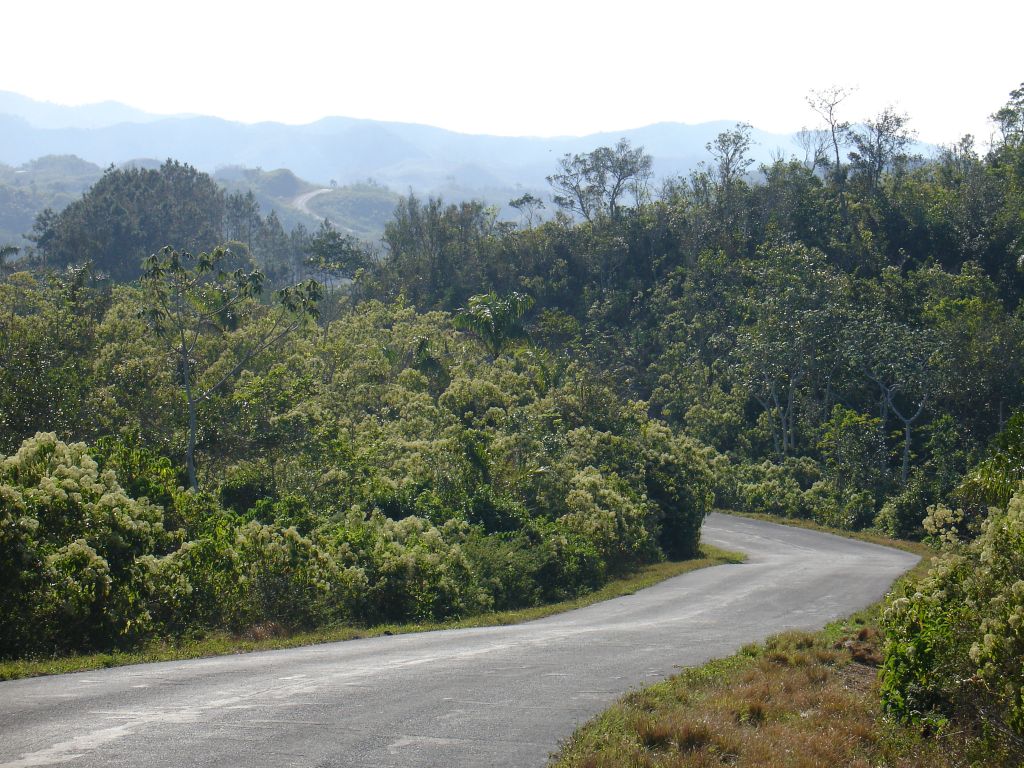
[548,138,653,221]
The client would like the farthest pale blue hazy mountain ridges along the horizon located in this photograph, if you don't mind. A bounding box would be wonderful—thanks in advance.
[0,92,799,195]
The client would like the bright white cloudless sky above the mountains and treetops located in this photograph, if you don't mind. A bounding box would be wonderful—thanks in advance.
[0,0,1024,143]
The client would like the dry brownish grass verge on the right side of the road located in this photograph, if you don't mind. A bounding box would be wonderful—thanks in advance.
[551,528,983,768]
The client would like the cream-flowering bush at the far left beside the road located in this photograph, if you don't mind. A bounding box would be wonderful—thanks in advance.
[0,433,169,655]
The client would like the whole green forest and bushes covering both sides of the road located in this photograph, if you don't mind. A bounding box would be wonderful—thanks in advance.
[0,86,1024,765]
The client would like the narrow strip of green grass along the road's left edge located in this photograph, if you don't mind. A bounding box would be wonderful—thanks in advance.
[0,545,744,680]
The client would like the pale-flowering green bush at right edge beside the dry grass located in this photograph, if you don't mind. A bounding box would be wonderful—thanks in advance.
[882,494,1024,757]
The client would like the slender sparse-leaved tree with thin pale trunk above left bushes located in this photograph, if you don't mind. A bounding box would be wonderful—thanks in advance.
[142,246,321,490]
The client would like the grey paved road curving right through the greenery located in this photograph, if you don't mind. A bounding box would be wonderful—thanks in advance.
[0,515,915,768]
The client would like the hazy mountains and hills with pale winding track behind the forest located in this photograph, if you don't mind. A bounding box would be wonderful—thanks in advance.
[0,91,933,245]
